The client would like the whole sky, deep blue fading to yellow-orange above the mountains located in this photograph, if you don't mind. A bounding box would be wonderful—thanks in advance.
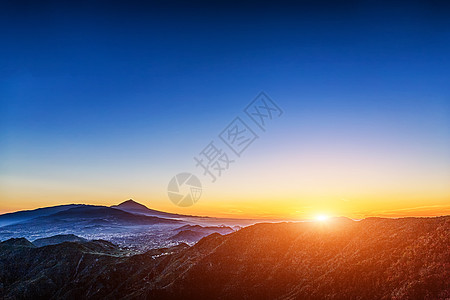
[0,0,450,219]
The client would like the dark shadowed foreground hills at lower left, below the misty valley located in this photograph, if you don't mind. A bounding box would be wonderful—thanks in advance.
[0,240,188,299]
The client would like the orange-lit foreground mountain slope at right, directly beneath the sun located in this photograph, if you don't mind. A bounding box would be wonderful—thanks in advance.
[163,217,450,299]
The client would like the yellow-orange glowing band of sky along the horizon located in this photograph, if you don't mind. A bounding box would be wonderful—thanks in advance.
[0,172,450,220]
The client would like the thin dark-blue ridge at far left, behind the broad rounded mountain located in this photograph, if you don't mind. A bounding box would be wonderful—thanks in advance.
[0,204,81,227]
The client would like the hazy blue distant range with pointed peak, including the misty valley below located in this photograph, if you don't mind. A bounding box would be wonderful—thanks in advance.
[0,199,239,252]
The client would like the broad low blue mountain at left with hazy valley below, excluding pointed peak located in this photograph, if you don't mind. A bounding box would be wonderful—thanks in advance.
[0,205,186,252]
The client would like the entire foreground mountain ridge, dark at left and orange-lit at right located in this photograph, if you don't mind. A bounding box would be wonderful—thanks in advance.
[0,216,450,299]
